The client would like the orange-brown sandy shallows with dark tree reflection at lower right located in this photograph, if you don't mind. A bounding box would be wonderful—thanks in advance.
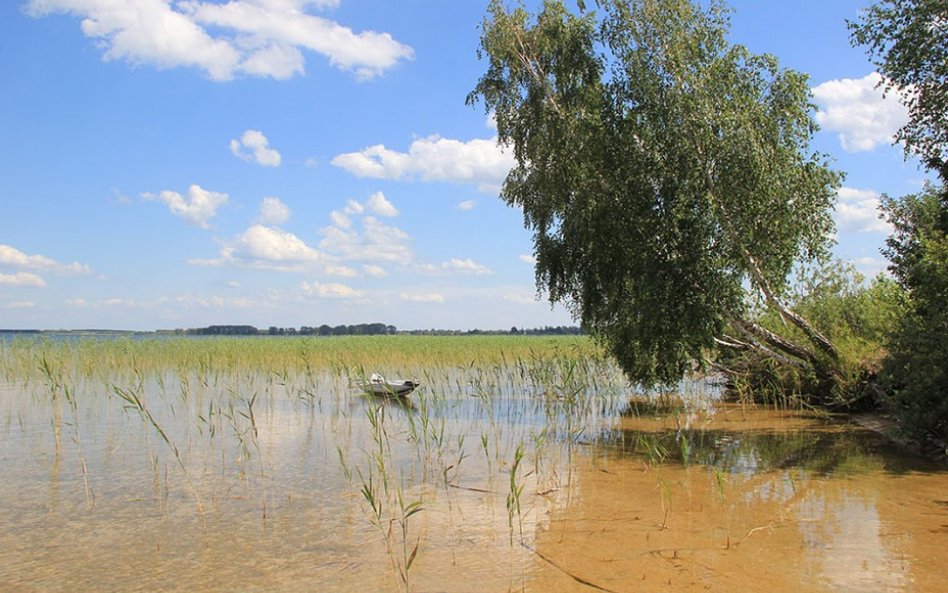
[530,404,948,593]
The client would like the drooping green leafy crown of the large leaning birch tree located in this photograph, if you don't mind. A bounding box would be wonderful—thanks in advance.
[469,0,838,385]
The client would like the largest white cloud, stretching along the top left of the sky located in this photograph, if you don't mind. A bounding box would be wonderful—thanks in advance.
[26,0,414,81]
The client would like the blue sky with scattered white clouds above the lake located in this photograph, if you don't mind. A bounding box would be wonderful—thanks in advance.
[0,0,925,330]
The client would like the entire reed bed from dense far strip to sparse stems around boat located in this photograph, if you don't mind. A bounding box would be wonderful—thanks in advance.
[0,336,628,591]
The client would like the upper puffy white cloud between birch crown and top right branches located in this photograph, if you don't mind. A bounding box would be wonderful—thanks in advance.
[813,72,908,152]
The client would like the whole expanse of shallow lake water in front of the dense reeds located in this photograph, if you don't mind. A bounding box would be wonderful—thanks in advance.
[0,369,948,593]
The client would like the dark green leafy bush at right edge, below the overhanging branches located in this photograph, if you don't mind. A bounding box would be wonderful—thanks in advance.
[883,186,948,441]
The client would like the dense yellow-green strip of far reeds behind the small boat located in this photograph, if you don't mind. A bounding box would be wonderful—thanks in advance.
[0,336,605,380]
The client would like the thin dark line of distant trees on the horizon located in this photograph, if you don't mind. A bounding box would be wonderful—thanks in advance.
[173,323,583,336]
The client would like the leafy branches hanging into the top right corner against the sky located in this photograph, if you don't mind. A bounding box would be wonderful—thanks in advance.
[849,0,948,176]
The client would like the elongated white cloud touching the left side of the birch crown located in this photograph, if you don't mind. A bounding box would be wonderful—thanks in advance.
[332,135,514,192]
